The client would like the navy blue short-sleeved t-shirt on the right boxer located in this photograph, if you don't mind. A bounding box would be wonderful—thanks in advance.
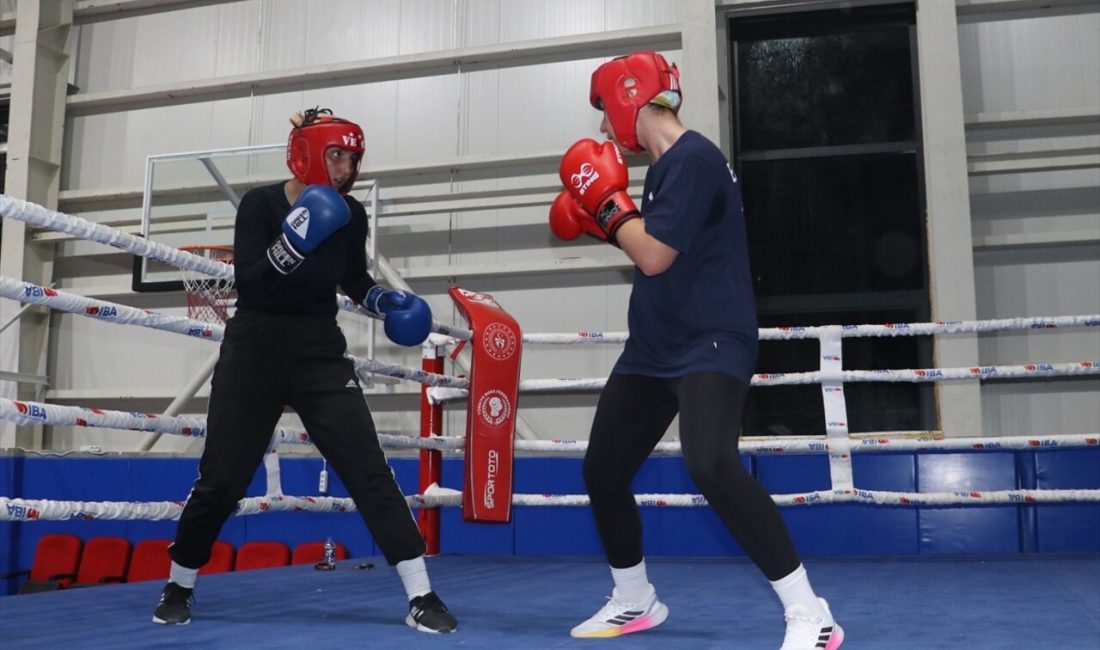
[613,131,758,384]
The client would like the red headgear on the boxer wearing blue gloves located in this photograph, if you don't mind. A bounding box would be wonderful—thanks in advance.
[286,109,363,194]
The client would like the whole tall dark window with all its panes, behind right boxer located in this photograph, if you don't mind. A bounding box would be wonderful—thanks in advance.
[728,4,935,434]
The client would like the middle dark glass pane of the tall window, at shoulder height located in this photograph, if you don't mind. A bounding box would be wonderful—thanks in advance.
[741,154,926,294]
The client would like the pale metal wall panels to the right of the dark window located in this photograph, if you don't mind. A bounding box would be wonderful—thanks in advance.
[959,4,1100,433]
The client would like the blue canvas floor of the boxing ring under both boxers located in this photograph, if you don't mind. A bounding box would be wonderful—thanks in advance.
[0,554,1100,650]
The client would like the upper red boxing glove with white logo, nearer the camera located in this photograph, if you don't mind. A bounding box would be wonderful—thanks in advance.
[558,137,640,244]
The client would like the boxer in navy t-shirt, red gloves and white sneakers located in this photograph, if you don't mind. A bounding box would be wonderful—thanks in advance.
[550,52,844,650]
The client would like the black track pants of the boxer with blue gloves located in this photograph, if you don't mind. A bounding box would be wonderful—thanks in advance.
[168,311,425,569]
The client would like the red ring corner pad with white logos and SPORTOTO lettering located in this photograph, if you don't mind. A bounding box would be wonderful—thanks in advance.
[449,287,523,524]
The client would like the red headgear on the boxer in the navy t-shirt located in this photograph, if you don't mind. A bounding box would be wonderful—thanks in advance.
[589,51,681,153]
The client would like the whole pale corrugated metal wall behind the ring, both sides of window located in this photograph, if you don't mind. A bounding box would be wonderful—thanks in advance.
[0,0,1100,451]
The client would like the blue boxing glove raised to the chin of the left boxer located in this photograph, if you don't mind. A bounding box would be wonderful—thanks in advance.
[267,185,351,275]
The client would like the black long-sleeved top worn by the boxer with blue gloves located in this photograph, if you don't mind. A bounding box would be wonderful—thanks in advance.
[233,183,376,317]
